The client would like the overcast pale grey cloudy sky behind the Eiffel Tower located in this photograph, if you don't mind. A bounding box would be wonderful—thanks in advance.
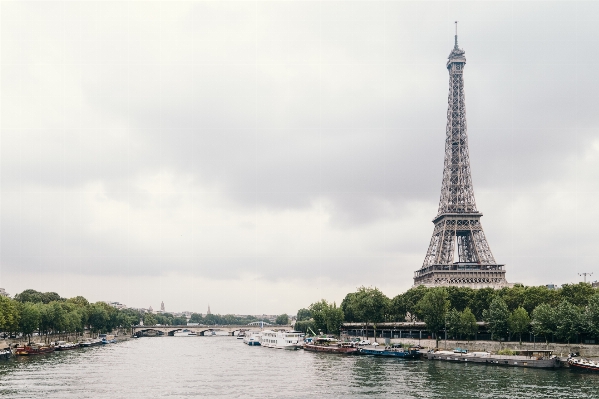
[0,0,599,314]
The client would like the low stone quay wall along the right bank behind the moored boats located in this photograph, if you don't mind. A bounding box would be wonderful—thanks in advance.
[364,337,599,357]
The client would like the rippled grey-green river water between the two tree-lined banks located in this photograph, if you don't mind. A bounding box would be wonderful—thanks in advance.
[0,337,599,399]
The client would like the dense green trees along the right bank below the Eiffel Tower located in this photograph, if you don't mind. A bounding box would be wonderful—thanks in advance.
[295,283,599,347]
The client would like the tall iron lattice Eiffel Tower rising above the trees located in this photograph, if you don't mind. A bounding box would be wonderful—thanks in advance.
[414,21,509,288]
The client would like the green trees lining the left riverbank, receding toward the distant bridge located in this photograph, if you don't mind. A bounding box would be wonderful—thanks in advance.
[0,289,274,343]
